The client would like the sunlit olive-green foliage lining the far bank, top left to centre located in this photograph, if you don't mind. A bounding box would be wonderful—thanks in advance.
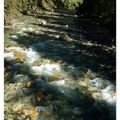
[4,0,83,24]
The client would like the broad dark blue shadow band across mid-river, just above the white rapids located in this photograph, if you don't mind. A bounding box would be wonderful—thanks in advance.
[10,28,115,82]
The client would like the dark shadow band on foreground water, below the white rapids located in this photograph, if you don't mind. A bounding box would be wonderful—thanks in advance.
[5,60,115,120]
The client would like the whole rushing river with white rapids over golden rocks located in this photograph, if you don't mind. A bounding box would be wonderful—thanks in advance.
[4,8,116,120]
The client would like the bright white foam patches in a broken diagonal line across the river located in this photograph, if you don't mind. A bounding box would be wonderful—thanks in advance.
[4,46,116,106]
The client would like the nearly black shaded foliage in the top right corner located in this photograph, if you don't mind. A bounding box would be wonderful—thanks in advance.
[78,0,116,33]
